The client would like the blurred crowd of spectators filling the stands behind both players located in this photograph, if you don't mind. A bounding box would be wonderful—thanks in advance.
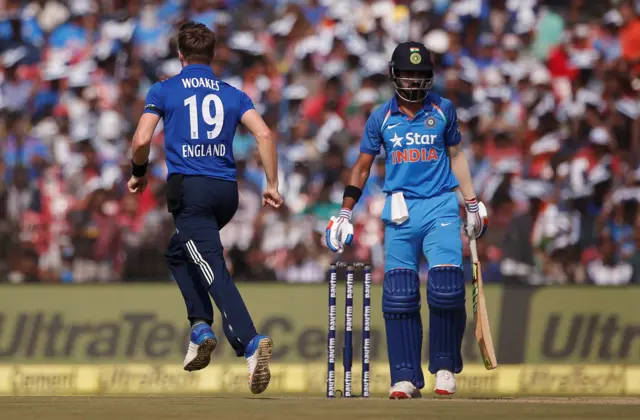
[0,0,640,285]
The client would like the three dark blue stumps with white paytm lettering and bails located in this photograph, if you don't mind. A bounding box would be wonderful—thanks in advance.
[327,262,371,398]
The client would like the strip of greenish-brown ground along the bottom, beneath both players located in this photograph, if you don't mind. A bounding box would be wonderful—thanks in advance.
[0,395,640,420]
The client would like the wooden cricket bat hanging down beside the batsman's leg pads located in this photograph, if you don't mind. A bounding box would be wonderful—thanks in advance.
[469,239,498,370]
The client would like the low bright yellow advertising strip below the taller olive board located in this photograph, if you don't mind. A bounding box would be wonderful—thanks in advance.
[0,363,640,396]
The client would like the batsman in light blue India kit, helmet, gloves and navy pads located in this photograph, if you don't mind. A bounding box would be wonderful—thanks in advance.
[326,42,487,399]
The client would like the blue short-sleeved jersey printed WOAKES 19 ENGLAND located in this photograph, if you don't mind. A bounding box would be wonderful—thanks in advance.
[144,64,254,181]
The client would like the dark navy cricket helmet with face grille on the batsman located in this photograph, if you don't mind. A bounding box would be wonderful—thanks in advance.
[389,42,434,102]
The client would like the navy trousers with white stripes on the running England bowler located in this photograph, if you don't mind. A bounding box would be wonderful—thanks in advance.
[166,175,257,356]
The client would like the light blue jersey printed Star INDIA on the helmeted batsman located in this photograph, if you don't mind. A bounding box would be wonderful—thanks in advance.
[360,92,461,198]
